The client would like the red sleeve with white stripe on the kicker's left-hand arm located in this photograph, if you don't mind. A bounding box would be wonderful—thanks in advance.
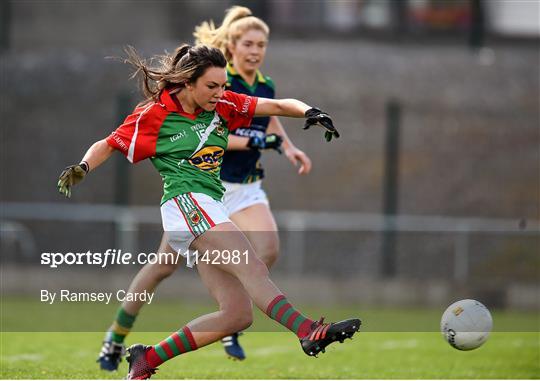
[107,103,167,163]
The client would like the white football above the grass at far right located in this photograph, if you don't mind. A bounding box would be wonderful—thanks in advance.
[441,299,493,351]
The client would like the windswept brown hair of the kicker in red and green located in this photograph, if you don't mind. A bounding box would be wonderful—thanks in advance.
[124,44,227,103]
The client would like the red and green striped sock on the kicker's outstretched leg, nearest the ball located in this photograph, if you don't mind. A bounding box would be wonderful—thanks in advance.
[266,295,313,339]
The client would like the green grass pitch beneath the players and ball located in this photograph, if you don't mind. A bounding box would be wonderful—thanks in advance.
[0,300,540,379]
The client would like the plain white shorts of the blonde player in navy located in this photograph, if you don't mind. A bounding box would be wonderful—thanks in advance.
[223,180,269,216]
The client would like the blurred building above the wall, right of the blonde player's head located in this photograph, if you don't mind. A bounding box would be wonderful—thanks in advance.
[265,0,540,38]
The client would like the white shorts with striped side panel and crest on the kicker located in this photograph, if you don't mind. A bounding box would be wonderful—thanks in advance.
[161,192,231,258]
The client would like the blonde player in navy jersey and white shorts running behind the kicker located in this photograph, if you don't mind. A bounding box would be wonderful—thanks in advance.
[98,6,311,370]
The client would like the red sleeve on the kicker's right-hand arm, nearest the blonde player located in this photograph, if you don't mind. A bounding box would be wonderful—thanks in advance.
[216,90,259,131]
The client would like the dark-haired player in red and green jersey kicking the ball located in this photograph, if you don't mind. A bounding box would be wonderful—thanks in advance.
[58,45,360,379]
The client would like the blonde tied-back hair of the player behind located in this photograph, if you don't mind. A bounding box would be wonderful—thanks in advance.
[193,5,270,61]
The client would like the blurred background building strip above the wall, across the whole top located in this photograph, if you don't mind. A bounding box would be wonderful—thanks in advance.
[0,0,540,51]
